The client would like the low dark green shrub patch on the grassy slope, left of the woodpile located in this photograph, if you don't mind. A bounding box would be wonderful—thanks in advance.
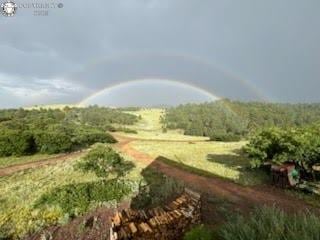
[34,179,131,217]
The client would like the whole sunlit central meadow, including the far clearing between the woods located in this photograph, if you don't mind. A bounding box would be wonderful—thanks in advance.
[117,109,267,185]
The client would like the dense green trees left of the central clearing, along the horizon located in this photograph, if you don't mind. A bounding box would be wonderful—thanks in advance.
[0,106,137,156]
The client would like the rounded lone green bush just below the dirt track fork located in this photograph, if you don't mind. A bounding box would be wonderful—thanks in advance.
[77,144,133,177]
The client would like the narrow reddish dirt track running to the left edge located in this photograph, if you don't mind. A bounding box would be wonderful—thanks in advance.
[0,152,84,177]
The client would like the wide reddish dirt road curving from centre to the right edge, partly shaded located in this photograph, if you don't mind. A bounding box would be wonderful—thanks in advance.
[116,136,318,211]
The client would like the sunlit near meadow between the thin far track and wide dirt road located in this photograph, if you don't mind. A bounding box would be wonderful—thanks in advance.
[131,141,267,185]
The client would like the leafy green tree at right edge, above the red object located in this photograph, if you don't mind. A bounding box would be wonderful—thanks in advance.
[244,125,320,172]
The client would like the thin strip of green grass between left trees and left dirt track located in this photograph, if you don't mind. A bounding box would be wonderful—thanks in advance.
[0,153,59,168]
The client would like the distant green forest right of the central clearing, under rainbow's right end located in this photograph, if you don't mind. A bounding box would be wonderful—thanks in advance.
[162,100,320,141]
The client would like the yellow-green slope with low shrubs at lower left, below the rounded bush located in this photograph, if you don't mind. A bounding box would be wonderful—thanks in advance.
[0,145,141,239]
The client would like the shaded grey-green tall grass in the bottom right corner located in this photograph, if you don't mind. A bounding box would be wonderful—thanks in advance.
[220,207,320,240]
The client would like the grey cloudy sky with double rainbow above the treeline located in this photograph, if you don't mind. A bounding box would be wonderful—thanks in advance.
[0,0,320,108]
